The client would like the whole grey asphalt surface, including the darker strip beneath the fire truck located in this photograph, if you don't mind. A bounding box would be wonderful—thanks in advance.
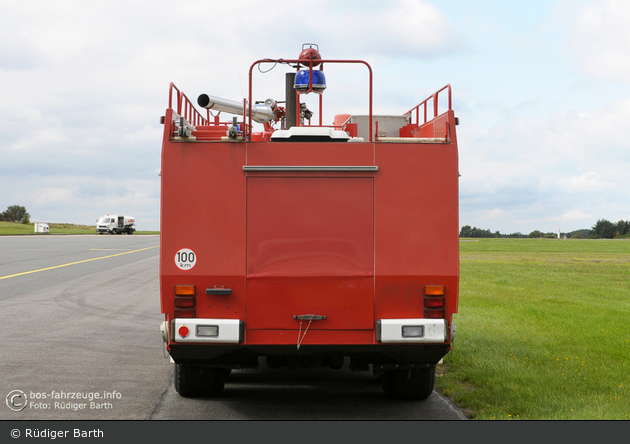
[0,235,465,421]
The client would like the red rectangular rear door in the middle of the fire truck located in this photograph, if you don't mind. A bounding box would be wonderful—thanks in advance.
[246,177,374,330]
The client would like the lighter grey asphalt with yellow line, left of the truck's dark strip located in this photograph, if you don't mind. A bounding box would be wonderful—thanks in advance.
[0,235,171,420]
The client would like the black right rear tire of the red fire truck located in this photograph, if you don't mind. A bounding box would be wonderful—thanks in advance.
[382,365,435,400]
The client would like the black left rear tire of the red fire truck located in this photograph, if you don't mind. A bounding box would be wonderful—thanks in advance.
[174,364,226,398]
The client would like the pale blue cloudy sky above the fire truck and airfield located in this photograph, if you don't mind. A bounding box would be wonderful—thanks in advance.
[0,0,630,234]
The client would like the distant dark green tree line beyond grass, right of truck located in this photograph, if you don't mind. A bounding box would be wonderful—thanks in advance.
[459,219,630,239]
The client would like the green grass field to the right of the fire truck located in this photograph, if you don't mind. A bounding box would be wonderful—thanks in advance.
[436,239,630,420]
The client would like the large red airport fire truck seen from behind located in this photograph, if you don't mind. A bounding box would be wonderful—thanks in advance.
[160,44,459,399]
